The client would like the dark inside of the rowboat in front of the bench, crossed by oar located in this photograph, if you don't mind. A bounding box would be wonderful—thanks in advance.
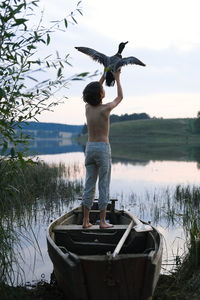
[53,224,150,255]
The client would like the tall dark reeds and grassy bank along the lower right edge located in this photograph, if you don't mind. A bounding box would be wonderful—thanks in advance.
[154,185,200,300]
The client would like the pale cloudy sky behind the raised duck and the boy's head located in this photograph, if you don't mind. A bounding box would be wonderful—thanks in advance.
[34,0,200,125]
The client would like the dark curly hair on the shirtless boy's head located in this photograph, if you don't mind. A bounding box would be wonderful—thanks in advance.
[83,81,102,106]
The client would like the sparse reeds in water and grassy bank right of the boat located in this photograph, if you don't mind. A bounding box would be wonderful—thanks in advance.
[124,185,200,300]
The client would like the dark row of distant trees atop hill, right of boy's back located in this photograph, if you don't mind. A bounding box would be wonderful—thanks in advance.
[82,113,151,134]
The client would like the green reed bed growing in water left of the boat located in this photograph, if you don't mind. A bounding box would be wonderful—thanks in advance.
[0,160,82,285]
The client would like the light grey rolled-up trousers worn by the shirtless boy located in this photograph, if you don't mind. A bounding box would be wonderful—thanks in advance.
[83,142,111,210]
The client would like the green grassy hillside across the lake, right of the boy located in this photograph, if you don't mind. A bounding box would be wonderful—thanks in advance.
[110,119,200,145]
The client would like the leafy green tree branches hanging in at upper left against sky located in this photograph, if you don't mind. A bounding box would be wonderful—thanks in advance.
[0,0,88,159]
